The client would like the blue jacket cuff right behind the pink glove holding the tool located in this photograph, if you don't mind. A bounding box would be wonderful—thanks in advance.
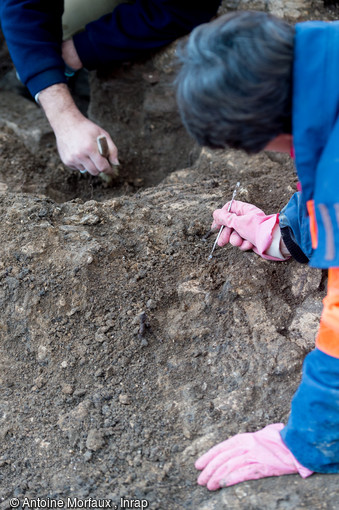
[279,192,312,264]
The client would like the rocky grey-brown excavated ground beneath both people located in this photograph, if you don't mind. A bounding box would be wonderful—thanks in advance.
[0,2,339,510]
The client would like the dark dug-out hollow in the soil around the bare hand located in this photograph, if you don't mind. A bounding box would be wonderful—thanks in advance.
[0,67,200,203]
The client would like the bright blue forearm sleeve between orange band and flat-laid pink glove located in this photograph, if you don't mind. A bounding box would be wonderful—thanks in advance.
[280,349,339,473]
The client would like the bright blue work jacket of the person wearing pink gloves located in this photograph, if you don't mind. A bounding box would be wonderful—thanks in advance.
[279,21,339,473]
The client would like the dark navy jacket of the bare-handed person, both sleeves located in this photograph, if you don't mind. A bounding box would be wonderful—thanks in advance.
[0,0,221,96]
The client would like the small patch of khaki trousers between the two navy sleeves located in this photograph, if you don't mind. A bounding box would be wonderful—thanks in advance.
[62,0,128,40]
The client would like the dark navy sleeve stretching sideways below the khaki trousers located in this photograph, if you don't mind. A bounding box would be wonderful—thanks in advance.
[73,0,221,69]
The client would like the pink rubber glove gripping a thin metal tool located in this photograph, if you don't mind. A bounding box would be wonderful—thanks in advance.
[212,200,284,260]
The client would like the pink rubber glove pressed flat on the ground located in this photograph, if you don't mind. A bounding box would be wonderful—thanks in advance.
[195,423,313,491]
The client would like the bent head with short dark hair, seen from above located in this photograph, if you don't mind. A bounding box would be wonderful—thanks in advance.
[176,11,294,153]
